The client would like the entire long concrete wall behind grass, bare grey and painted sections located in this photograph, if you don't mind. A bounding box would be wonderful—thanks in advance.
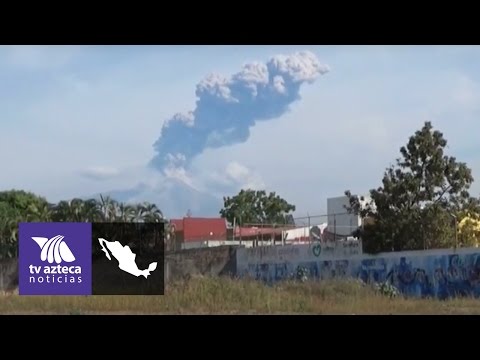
[4,244,480,299]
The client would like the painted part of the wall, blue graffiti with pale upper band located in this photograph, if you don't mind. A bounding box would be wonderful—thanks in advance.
[237,244,480,299]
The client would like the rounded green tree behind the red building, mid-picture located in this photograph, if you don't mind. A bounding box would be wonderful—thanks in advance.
[220,189,295,225]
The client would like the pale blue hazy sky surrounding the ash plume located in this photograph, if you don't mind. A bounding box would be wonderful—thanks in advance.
[0,46,480,215]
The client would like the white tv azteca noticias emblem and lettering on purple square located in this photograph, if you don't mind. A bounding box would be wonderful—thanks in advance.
[28,235,82,284]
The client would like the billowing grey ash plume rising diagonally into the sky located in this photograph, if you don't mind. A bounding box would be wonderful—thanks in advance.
[151,51,329,170]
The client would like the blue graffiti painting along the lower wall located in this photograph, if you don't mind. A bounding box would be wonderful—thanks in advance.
[242,249,480,299]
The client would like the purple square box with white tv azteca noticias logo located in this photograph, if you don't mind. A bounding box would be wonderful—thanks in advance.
[18,222,92,295]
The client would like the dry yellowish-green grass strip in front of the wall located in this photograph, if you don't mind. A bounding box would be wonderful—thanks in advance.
[0,278,480,315]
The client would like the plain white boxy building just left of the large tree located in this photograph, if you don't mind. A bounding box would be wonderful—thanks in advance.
[327,196,371,236]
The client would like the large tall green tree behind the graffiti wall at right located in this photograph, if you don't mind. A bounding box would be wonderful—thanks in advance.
[345,122,478,253]
